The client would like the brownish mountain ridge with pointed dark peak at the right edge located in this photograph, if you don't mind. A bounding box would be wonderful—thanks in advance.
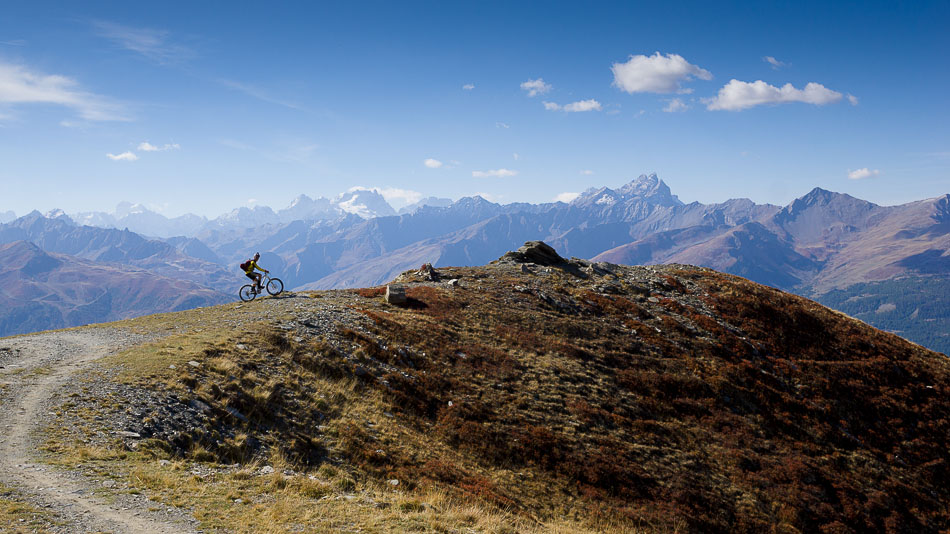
[595,188,950,294]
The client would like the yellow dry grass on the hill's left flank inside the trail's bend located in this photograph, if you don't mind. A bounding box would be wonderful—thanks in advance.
[45,304,652,534]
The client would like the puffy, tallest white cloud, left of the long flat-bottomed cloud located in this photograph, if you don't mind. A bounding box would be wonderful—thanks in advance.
[610,52,712,93]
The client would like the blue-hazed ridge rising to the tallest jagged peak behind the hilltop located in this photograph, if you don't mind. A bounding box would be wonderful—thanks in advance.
[297,174,778,289]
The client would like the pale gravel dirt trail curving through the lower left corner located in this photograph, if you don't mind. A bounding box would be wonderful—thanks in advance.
[0,328,194,534]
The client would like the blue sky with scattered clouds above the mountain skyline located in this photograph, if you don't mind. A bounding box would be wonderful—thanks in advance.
[0,1,950,216]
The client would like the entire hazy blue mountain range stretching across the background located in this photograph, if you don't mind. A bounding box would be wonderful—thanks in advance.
[0,174,950,352]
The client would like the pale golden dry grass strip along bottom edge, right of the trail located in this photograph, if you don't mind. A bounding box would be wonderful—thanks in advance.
[122,456,634,534]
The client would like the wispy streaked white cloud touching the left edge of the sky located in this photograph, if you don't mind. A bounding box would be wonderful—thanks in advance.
[0,63,128,121]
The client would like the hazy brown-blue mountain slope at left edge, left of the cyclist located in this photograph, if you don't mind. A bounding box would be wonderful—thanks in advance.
[0,241,231,336]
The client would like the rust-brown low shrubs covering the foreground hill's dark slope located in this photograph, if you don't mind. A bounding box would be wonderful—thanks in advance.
[41,265,950,533]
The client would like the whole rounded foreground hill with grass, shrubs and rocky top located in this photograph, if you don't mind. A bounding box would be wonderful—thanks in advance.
[0,242,950,533]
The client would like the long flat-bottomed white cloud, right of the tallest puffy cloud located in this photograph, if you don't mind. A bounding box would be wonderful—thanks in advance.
[704,79,841,111]
